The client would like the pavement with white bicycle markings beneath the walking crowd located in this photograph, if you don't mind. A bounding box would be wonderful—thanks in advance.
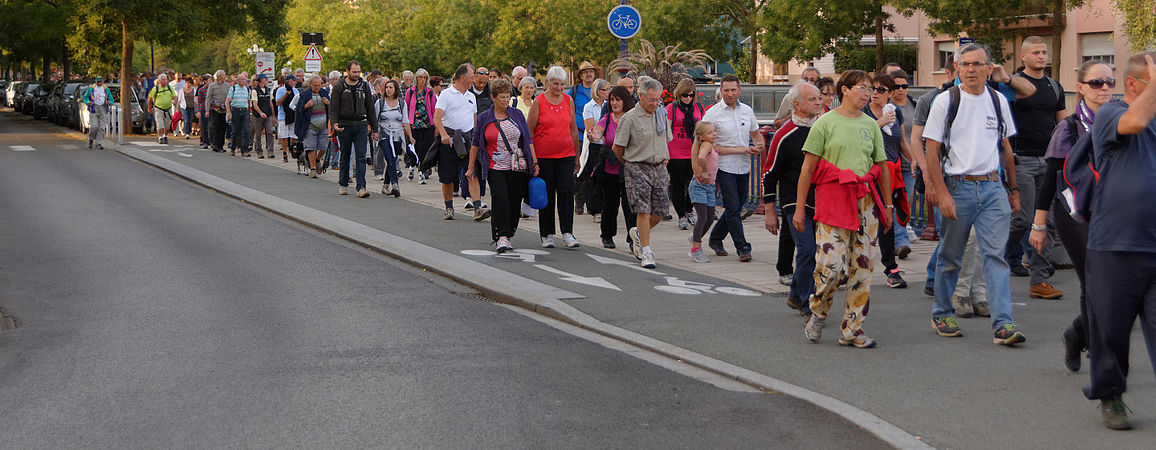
[9,111,1156,448]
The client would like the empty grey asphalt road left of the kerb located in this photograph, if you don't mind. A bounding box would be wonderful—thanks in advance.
[0,113,881,448]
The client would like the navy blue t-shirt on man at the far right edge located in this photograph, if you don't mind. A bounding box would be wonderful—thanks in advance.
[1088,102,1156,253]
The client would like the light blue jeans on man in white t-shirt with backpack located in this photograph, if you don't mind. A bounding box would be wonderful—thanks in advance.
[932,177,1014,329]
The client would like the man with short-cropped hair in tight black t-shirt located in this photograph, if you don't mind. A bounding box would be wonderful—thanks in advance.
[1005,36,1067,300]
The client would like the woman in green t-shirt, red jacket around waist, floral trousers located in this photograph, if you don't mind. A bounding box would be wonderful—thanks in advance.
[792,71,895,348]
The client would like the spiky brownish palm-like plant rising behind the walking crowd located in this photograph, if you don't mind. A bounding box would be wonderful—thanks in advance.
[607,39,714,90]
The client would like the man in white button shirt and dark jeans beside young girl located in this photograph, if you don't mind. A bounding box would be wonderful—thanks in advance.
[702,75,765,263]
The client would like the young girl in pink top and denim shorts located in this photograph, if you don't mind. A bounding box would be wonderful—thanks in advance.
[688,121,719,263]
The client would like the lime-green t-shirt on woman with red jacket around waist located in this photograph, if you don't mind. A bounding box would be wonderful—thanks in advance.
[802,110,887,176]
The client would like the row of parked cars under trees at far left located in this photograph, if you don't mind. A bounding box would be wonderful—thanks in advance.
[0,80,145,133]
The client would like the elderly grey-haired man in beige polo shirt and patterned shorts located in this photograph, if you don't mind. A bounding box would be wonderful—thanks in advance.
[613,76,674,268]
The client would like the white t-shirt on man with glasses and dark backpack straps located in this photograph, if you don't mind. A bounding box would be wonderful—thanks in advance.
[924,88,1016,175]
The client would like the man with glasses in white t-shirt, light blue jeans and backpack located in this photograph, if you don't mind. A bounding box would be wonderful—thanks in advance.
[922,44,1027,346]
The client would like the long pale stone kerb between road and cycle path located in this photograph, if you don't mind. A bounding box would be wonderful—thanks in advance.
[115,145,932,449]
